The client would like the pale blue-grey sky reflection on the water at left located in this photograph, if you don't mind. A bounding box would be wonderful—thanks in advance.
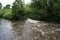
[0,19,13,40]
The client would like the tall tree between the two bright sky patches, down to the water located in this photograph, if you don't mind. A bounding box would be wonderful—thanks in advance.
[12,0,25,19]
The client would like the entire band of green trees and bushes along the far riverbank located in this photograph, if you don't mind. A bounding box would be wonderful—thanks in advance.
[0,0,60,22]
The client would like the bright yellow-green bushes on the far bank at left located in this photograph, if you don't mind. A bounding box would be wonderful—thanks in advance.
[0,9,13,19]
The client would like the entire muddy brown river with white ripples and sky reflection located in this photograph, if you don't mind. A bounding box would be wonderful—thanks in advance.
[0,19,60,40]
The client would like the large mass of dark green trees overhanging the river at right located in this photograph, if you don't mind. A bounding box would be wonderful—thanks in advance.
[29,0,60,22]
